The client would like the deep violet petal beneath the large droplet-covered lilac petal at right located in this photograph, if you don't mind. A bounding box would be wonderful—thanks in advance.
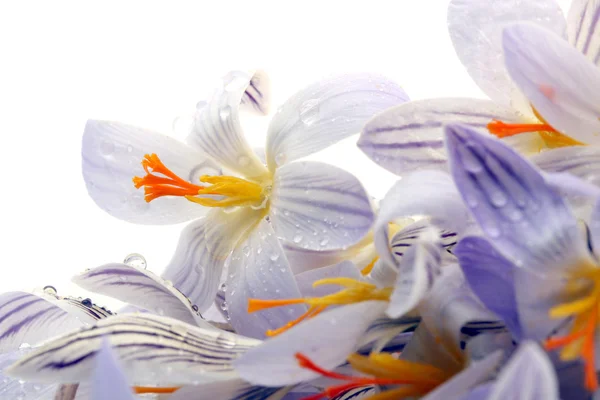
[453,236,522,340]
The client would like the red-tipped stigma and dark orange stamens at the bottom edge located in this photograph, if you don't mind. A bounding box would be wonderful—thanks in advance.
[296,353,451,400]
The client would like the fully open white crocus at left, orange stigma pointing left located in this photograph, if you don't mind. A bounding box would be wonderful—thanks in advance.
[82,73,407,332]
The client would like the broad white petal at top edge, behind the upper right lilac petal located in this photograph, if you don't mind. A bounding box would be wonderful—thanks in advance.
[448,0,566,115]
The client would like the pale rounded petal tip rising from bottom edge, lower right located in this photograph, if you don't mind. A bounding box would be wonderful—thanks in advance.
[488,341,560,400]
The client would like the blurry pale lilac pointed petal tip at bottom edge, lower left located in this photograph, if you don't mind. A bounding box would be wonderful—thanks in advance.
[91,339,134,400]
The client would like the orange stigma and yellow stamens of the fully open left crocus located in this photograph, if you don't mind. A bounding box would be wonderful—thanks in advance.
[133,154,269,208]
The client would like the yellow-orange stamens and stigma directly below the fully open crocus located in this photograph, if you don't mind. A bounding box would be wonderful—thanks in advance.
[248,278,393,336]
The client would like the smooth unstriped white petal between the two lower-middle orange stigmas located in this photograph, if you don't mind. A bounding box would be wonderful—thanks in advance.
[235,301,387,386]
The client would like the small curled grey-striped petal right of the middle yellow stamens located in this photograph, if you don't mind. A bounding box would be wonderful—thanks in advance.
[386,227,442,318]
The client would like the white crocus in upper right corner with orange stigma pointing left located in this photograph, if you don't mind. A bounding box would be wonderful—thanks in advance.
[358,0,600,174]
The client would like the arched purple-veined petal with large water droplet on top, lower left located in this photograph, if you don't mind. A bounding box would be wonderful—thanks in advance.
[73,263,212,329]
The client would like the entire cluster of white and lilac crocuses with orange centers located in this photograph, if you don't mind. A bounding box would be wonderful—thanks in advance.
[0,0,600,400]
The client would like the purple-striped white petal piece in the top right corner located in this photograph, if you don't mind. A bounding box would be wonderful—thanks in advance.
[567,0,600,66]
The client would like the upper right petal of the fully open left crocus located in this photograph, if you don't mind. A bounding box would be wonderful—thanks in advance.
[267,74,408,171]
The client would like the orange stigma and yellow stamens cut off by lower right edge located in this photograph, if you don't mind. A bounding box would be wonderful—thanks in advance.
[545,268,600,391]
